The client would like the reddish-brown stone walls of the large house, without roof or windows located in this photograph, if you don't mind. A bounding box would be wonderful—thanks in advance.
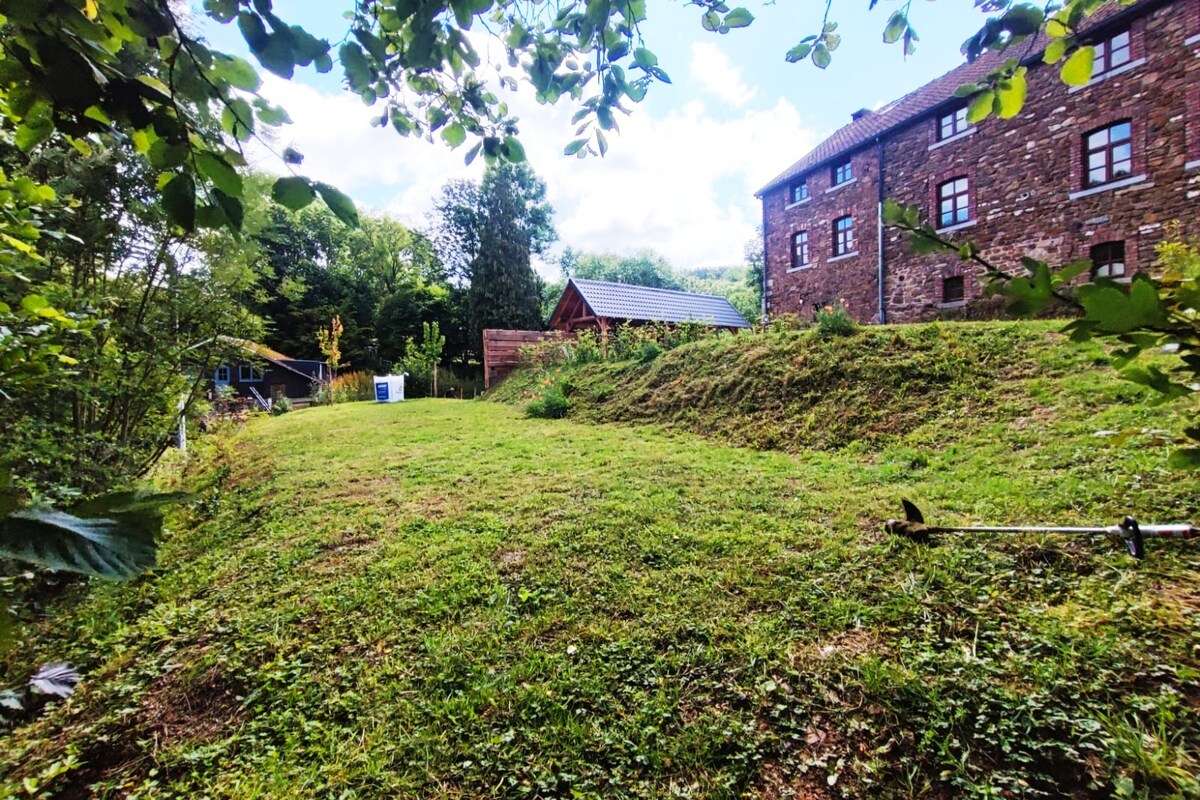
[763,0,1200,321]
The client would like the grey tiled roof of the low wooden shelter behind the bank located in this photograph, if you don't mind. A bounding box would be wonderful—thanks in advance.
[571,278,750,327]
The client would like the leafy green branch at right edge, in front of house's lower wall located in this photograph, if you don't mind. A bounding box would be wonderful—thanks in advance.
[883,200,1200,469]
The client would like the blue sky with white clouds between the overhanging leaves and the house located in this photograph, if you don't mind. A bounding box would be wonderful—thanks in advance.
[204,0,983,272]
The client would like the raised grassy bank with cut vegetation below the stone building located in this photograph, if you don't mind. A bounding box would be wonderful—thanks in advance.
[491,323,1140,452]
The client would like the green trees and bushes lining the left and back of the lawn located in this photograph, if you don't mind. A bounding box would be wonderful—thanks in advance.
[0,128,758,499]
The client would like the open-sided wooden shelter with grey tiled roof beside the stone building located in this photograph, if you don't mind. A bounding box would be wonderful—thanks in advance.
[550,278,750,333]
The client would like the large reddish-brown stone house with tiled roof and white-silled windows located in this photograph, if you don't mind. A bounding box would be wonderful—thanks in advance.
[757,0,1200,323]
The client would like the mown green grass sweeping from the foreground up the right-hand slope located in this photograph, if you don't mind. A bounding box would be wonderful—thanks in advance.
[0,326,1200,798]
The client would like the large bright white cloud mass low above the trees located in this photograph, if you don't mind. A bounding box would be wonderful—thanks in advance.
[248,78,816,275]
